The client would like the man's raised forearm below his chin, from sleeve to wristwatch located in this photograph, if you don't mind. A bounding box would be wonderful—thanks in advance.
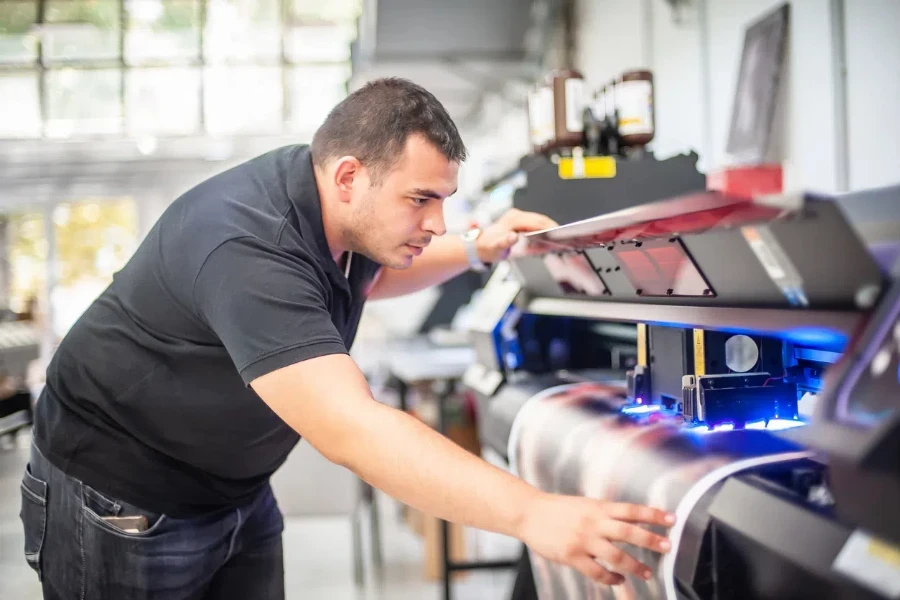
[369,235,469,300]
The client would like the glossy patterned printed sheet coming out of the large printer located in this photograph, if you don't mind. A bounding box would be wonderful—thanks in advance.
[509,382,805,600]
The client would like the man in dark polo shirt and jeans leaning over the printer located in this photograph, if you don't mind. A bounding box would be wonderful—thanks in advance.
[22,79,671,600]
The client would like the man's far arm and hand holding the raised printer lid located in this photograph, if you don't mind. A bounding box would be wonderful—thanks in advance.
[369,209,556,300]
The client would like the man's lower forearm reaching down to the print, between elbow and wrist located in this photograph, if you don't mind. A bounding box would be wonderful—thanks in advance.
[335,403,540,536]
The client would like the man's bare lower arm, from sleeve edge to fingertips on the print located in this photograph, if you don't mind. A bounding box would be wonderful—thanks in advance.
[251,354,672,584]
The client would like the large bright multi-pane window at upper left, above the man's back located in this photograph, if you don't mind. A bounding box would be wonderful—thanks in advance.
[0,0,361,139]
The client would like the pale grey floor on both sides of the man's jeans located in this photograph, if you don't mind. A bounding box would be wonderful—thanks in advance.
[0,433,515,600]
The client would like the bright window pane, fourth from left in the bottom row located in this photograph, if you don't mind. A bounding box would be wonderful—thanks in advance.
[204,67,283,133]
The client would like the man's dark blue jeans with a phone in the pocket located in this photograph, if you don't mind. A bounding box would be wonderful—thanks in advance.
[20,446,284,600]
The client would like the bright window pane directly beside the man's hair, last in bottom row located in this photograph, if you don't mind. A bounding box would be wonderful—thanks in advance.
[290,65,350,132]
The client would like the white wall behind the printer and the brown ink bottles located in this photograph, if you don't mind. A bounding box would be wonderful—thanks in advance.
[577,0,900,191]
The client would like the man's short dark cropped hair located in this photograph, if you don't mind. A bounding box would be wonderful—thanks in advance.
[310,77,466,181]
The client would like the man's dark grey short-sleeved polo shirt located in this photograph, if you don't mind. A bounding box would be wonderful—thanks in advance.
[35,146,379,515]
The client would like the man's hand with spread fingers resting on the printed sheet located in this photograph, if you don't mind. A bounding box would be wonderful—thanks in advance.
[518,494,674,585]
